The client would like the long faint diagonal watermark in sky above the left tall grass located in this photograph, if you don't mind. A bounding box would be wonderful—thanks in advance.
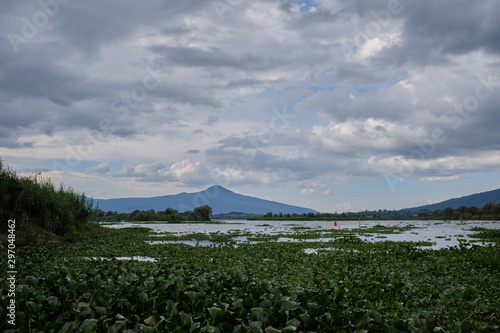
[52,65,163,175]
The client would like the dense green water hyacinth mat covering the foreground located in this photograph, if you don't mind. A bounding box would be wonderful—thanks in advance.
[0,226,500,333]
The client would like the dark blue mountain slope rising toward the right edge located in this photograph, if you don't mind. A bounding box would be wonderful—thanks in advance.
[403,189,500,212]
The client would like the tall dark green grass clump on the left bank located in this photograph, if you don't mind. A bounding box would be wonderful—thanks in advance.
[0,160,94,238]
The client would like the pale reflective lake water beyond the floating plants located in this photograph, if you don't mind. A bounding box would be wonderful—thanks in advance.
[105,220,500,249]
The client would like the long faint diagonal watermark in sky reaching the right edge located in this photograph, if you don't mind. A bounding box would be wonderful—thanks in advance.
[385,73,500,193]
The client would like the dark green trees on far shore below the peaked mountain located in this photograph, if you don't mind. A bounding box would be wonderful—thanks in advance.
[93,205,212,222]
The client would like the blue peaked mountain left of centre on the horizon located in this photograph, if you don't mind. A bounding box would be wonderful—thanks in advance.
[94,186,316,214]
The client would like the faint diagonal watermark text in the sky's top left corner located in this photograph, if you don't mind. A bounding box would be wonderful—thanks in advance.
[7,0,71,54]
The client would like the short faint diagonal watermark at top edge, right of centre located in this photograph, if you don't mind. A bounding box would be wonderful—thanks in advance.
[340,0,412,60]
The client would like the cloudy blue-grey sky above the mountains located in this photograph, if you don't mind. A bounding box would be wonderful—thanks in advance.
[0,0,500,212]
